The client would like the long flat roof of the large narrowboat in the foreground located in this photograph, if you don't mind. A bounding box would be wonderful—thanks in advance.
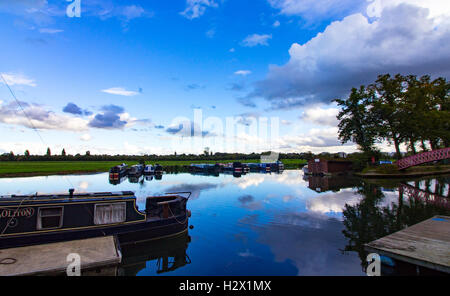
[0,191,135,203]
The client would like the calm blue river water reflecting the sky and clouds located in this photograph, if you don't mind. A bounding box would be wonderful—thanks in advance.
[0,170,450,275]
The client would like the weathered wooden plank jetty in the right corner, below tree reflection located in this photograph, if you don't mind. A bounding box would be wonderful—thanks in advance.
[365,216,450,273]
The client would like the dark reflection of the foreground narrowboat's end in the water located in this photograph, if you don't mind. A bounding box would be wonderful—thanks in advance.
[119,232,191,276]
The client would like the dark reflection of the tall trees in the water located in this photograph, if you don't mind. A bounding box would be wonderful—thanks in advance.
[342,176,450,271]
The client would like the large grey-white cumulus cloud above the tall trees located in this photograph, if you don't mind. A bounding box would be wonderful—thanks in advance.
[246,1,450,109]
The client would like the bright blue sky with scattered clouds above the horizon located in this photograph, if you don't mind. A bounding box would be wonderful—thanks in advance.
[0,0,450,154]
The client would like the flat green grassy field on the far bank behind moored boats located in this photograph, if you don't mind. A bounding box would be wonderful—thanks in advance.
[0,159,306,177]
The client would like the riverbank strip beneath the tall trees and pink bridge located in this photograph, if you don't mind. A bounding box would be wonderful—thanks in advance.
[354,165,450,179]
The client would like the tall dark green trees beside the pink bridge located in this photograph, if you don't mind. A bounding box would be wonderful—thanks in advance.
[335,74,450,159]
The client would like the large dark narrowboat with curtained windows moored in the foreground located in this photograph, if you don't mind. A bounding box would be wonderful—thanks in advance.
[0,190,190,249]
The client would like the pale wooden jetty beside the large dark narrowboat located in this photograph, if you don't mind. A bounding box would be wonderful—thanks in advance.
[0,236,122,276]
